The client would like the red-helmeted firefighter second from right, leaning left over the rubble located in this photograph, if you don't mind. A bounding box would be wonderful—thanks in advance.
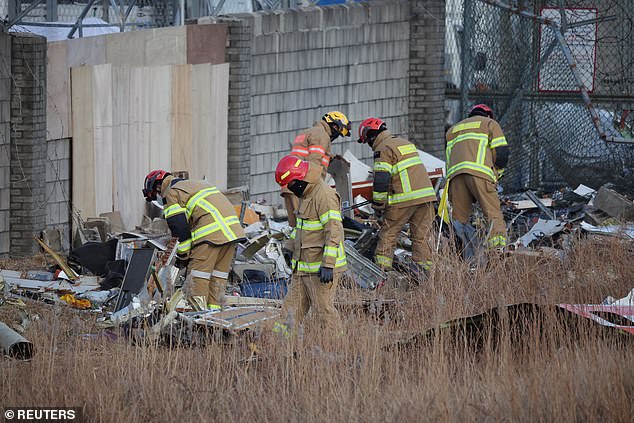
[358,118,436,273]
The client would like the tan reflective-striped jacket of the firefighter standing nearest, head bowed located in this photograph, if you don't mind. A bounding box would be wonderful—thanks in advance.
[289,178,346,274]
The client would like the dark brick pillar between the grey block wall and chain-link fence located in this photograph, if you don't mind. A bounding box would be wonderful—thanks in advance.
[409,0,445,158]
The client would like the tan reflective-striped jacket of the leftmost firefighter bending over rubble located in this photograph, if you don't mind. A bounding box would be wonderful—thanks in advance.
[161,176,245,255]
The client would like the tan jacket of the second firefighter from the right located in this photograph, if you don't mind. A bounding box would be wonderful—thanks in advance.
[372,131,436,208]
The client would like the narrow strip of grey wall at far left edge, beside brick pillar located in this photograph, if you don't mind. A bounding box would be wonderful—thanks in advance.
[0,31,11,257]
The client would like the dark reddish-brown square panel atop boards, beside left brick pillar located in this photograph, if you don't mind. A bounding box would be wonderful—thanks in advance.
[186,24,227,65]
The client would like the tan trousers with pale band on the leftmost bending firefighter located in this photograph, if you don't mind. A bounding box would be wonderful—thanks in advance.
[189,242,236,306]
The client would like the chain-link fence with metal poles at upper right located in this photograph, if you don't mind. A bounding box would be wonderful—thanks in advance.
[447,0,634,192]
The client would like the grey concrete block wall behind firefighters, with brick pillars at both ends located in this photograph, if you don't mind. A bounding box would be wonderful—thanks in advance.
[205,0,445,203]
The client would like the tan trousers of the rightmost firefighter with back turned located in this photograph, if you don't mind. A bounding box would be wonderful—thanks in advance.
[449,173,506,246]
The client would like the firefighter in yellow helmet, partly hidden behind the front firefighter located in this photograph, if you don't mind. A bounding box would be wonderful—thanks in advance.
[282,111,350,227]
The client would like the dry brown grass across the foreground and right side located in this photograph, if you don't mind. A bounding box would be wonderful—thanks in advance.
[0,237,634,422]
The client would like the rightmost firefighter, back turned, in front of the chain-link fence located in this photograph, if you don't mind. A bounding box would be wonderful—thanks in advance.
[446,104,509,249]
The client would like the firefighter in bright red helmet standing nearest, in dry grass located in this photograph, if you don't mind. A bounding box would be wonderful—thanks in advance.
[273,156,346,335]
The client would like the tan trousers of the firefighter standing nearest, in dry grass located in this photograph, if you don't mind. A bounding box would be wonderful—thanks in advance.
[281,273,341,333]
